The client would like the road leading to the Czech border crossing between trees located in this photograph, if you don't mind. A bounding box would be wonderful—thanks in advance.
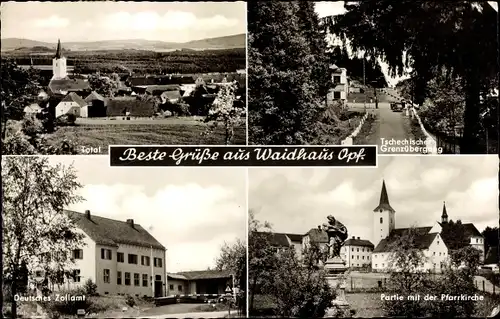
[348,89,424,154]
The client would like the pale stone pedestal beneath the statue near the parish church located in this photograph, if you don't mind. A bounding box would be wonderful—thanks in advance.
[324,257,349,317]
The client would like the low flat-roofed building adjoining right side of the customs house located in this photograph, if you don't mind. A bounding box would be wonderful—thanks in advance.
[167,270,234,296]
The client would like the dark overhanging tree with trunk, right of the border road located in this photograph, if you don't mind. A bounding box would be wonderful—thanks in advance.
[325,0,498,154]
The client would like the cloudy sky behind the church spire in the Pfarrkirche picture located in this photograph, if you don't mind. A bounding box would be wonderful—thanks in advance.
[252,155,498,246]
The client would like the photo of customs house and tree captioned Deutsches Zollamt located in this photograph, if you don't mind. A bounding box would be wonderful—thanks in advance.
[2,156,247,318]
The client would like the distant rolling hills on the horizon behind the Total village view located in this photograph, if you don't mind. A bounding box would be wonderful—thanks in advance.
[1,33,246,51]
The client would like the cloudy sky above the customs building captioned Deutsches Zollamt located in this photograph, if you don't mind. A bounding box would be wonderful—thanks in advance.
[50,156,247,272]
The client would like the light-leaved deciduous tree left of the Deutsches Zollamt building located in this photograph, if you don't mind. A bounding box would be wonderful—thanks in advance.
[2,157,86,318]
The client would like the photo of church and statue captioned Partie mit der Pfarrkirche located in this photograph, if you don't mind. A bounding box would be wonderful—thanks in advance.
[248,155,500,318]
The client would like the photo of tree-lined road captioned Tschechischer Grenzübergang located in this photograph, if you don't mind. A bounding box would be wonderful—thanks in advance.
[248,0,500,154]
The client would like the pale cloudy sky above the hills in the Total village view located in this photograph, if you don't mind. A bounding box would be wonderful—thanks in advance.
[1,1,246,43]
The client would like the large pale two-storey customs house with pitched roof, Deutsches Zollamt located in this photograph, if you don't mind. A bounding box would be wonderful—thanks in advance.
[33,211,167,297]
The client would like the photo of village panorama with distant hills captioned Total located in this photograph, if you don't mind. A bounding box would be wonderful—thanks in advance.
[1,1,247,155]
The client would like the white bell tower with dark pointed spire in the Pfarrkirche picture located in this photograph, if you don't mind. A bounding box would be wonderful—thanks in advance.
[372,181,396,247]
